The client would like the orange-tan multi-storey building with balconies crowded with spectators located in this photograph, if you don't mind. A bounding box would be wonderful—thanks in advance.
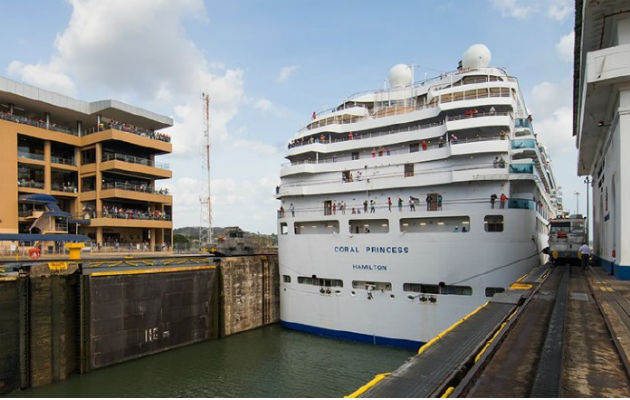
[0,77,173,250]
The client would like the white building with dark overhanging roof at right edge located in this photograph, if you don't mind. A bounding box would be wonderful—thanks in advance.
[573,0,630,279]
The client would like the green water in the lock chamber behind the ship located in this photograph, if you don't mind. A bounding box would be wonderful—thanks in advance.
[11,325,413,397]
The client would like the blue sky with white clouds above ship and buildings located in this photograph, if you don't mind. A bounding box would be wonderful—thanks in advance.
[0,0,586,233]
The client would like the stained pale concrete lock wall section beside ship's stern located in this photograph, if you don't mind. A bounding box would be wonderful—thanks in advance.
[220,254,280,336]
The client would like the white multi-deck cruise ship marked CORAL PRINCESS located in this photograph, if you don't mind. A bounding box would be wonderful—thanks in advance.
[276,44,560,347]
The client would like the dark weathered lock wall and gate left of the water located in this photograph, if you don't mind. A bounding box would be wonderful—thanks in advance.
[0,254,279,394]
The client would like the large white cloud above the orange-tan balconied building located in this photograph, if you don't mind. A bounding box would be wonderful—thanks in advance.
[8,0,244,156]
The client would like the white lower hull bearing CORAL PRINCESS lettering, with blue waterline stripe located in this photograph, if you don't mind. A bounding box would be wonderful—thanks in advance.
[279,210,546,347]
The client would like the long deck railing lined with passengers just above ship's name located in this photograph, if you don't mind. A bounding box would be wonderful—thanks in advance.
[277,194,539,218]
